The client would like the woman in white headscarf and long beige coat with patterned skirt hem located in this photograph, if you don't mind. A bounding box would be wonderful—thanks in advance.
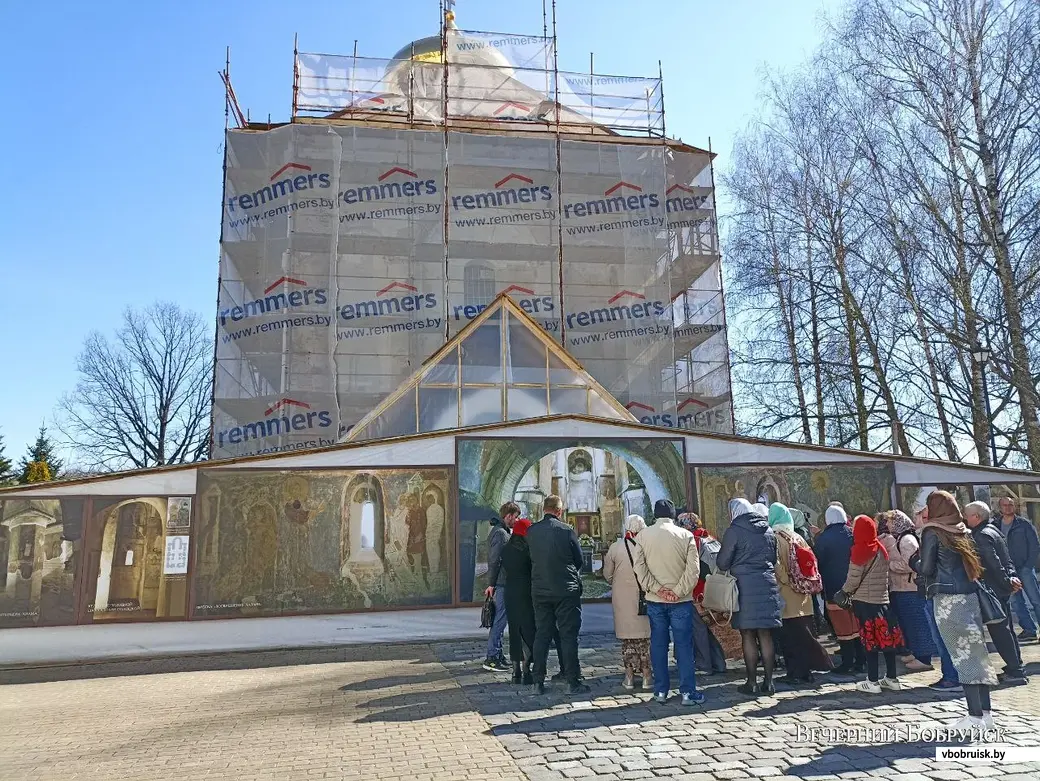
[601,515,653,689]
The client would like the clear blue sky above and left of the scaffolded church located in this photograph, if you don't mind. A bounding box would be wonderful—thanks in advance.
[0,0,838,458]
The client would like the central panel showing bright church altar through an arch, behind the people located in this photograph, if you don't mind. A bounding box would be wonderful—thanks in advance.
[457,438,686,602]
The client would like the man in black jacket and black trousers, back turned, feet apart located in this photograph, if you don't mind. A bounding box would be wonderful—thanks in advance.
[527,494,591,694]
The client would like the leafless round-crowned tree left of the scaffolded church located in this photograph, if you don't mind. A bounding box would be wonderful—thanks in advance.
[57,303,212,470]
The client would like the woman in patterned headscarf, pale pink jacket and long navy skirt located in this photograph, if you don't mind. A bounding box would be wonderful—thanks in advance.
[878,510,938,673]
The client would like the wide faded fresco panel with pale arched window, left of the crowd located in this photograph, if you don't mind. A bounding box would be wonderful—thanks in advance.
[192,469,454,618]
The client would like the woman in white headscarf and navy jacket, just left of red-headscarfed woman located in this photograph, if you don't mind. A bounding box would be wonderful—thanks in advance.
[814,501,866,675]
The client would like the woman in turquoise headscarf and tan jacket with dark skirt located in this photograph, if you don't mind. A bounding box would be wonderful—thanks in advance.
[769,502,831,685]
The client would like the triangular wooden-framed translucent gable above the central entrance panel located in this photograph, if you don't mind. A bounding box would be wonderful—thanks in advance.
[345,293,635,442]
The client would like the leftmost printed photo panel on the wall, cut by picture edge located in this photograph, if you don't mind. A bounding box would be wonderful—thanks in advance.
[0,497,84,628]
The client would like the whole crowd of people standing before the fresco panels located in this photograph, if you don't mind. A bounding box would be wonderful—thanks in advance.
[485,491,1040,729]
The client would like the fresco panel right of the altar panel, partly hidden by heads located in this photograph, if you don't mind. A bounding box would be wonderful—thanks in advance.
[696,463,895,536]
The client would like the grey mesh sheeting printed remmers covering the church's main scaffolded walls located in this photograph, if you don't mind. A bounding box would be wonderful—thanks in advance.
[213,124,730,458]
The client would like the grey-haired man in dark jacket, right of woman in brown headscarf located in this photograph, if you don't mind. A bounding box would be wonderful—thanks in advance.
[964,501,1026,684]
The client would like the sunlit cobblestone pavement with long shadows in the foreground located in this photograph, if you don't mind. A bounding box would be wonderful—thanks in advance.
[0,636,1040,781]
